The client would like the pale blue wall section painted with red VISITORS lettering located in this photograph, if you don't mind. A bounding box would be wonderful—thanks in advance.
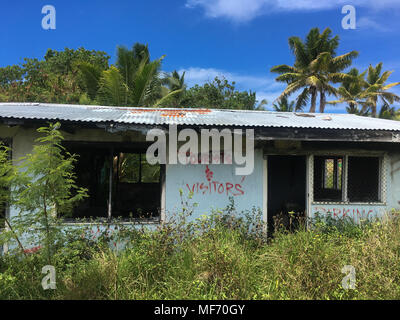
[166,150,263,218]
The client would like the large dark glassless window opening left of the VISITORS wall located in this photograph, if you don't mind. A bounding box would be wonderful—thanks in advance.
[65,142,162,220]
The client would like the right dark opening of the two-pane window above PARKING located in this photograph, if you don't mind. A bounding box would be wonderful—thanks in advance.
[347,157,381,202]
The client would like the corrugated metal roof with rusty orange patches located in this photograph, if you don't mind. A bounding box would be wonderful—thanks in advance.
[0,103,400,131]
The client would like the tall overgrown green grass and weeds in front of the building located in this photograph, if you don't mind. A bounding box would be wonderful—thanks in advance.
[0,205,400,299]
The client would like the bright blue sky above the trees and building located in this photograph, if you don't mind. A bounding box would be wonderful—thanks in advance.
[0,0,400,112]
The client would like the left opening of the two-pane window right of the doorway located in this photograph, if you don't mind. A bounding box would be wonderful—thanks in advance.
[314,156,343,201]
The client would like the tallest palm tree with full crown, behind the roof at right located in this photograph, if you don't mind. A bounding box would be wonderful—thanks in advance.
[271,28,358,112]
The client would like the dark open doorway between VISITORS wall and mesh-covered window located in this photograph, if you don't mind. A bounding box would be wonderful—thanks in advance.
[268,156,306,232]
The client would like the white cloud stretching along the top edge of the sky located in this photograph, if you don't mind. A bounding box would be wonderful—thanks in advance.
[186,0,400,22]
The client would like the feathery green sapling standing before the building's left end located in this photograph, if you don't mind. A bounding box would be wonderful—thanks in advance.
[5,123,87,263]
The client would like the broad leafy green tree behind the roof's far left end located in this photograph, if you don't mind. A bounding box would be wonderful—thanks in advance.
[0,48,110,103]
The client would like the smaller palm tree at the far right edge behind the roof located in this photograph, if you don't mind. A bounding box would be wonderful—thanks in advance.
[364,62,400,117]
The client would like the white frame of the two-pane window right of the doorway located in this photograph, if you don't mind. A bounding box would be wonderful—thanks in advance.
[309,152,387,206]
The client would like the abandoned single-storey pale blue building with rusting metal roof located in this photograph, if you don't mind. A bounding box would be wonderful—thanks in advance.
[0,103,400,230]
